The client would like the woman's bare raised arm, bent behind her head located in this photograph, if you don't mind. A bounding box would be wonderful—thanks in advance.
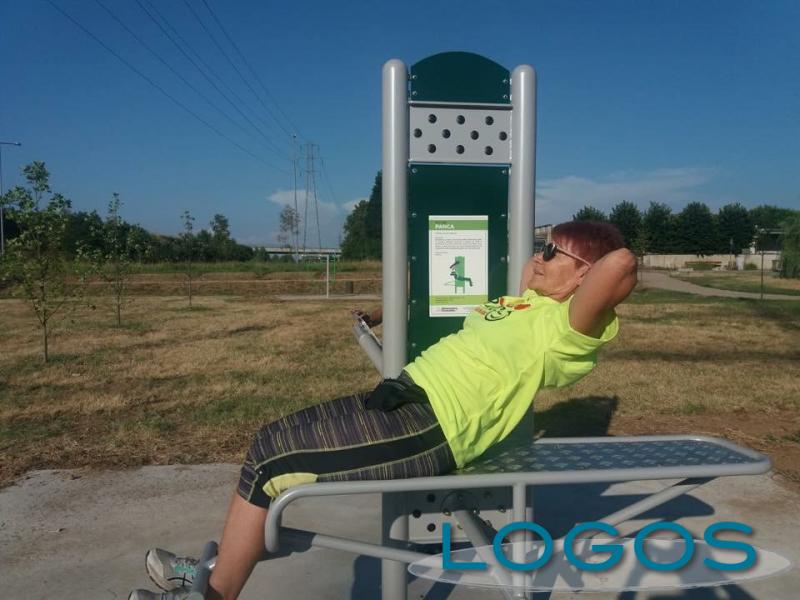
[569,248,636,337]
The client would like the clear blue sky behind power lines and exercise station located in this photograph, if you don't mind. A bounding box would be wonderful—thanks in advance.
[0,0,800,244]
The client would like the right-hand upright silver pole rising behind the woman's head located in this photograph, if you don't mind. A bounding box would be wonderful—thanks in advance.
[507,65,536,295]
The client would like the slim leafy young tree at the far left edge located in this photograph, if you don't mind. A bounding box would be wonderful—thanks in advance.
[0,161,81,362]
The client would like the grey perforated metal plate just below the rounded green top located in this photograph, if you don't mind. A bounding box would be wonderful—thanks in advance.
[409,104,511,165]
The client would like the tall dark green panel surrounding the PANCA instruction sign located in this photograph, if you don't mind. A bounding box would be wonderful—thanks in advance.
[407,163,508,362]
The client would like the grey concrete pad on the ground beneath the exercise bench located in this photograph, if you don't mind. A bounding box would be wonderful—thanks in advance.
[0,465,800,600]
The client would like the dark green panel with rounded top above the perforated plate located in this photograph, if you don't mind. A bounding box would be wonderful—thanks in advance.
[410,52,511,104]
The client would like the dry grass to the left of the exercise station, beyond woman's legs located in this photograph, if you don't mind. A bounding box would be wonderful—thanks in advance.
[0,297,377,482]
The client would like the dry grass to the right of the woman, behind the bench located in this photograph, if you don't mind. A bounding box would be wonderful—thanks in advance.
[536,294,800,482]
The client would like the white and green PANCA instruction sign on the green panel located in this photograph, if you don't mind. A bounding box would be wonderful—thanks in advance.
[428,215,489,317]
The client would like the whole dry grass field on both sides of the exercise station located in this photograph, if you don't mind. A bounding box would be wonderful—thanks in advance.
[0,276,800,484]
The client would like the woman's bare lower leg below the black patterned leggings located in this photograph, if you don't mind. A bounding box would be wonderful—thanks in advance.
[208,493,267,600]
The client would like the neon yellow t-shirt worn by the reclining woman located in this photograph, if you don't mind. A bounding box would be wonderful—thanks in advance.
[405,290,619,467]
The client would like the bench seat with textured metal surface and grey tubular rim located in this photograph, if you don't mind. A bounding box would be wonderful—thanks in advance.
[266,436,771,551]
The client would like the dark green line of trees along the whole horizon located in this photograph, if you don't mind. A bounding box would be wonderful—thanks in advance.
[4,163,800,263]
